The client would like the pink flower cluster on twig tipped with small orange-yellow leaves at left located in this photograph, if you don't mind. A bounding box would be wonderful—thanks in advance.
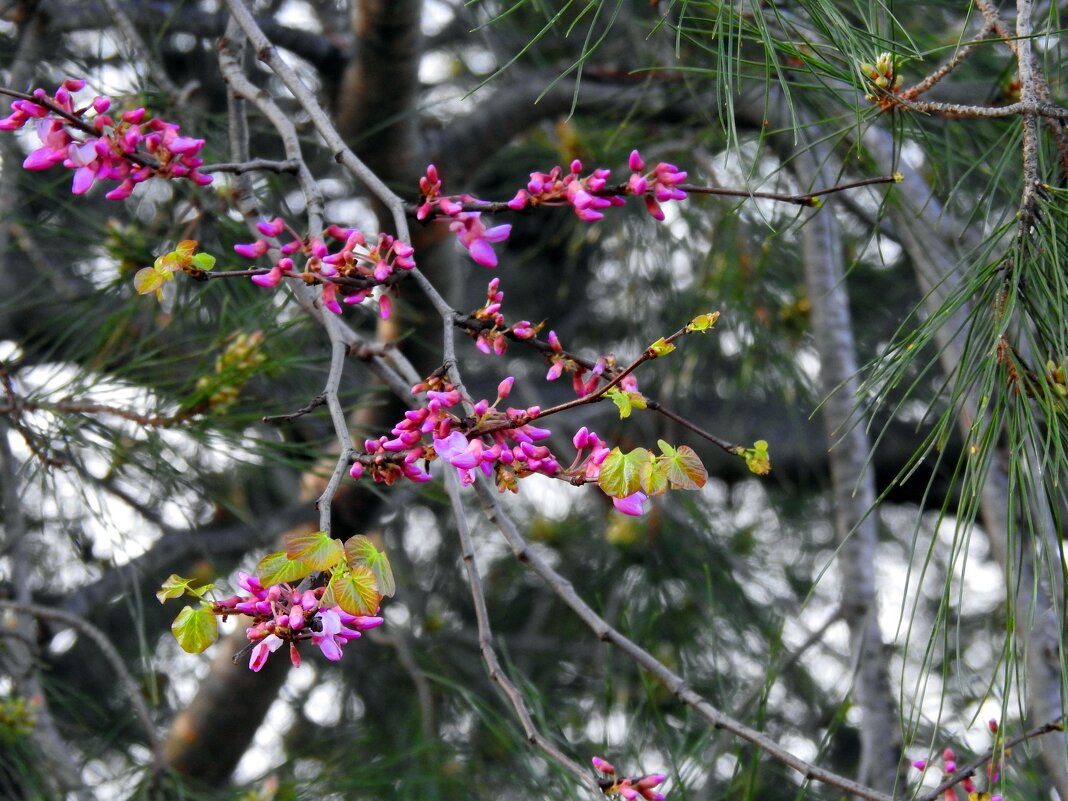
[234,217,415,319]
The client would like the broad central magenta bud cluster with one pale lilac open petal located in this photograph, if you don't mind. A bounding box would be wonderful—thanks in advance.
[350,376,560,491]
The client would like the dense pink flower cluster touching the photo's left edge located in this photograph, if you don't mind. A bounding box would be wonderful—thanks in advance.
[0,80,211,200]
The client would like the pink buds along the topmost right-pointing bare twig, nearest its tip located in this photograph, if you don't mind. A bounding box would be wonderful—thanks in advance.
[508,151,687,222]
